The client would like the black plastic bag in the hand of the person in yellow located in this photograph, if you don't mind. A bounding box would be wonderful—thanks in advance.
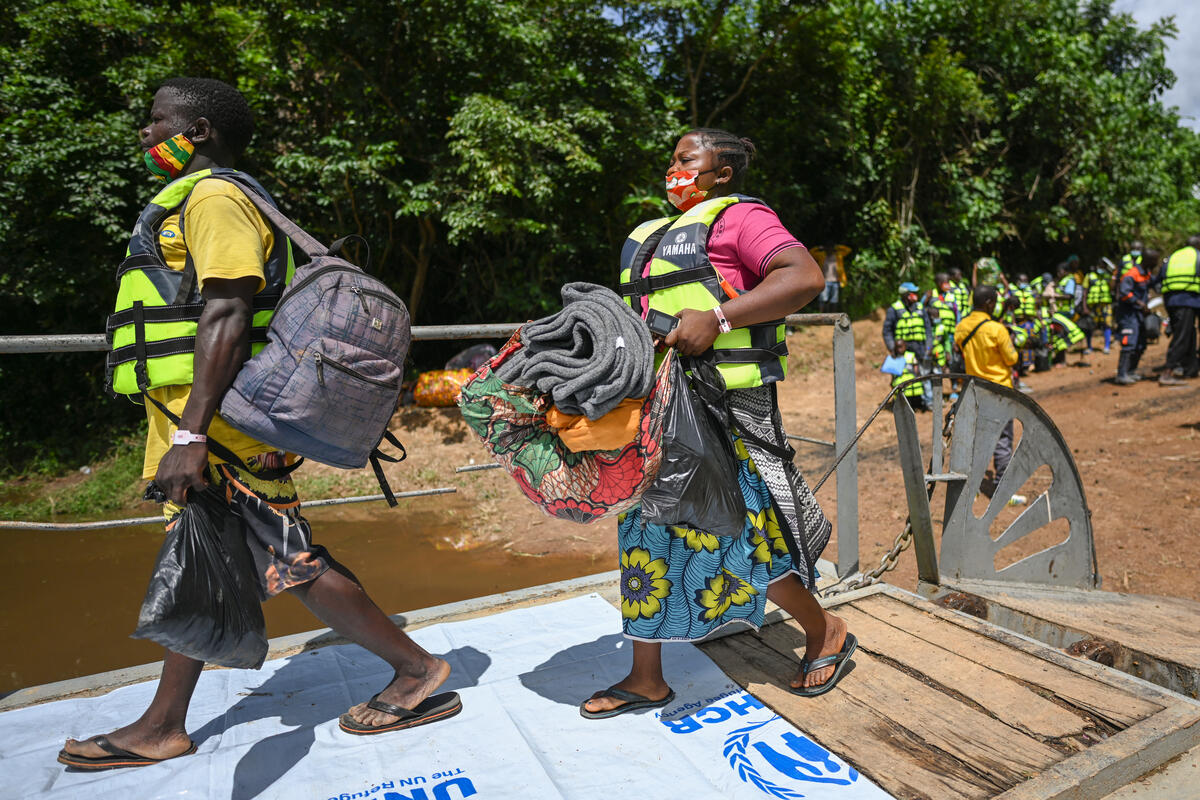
[133,485,268,669]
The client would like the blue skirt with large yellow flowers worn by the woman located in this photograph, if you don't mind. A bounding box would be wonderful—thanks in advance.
[617,435,794,642]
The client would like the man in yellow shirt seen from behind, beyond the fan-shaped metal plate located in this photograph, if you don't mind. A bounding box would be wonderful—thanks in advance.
[954,284,1018,498]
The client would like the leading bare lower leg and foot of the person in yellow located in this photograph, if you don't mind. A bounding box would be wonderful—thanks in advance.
[64,650,204,758]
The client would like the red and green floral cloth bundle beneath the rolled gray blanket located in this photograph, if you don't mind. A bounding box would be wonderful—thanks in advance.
[458,330,676,523]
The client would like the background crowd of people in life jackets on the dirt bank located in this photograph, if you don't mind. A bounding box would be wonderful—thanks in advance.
[883,234,1200,402]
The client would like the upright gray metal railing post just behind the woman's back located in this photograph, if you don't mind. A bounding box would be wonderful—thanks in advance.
[830,314,859,578]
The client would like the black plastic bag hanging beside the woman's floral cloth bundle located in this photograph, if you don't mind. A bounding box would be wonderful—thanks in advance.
[642,359,746,536]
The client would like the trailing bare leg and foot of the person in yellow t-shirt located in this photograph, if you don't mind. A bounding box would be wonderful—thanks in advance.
[289,565,450,726]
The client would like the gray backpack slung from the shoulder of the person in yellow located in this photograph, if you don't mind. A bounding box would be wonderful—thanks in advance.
[216,175,413,506]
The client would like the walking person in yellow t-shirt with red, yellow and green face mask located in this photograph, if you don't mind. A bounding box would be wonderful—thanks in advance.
[59,78,462,770]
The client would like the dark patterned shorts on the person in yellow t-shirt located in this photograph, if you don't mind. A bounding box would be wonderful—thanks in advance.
[162,464,330,600]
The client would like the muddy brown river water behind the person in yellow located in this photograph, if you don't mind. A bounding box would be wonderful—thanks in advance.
[0,506,600,694]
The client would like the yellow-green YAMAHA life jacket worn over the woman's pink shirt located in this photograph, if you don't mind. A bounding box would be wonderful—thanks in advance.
[619,194,787,389]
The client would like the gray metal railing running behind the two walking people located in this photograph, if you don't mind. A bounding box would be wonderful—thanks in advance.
[0,314,859,576]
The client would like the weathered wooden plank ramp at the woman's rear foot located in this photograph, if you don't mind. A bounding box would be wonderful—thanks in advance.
[701,584,1200,800]
